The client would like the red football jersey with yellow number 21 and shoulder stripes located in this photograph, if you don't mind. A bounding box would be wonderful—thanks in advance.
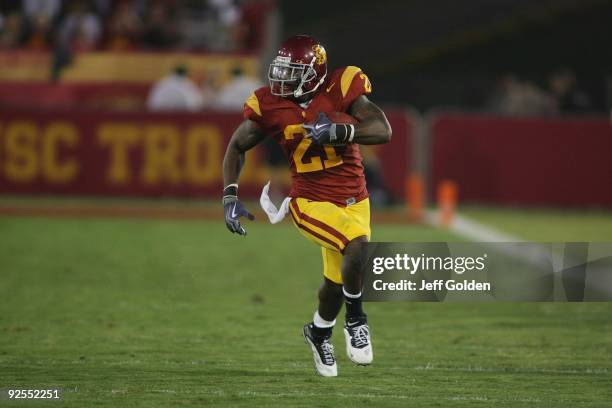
[244,66,372,206]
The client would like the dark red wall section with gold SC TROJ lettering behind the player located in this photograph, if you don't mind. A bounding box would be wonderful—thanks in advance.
[0,110,412,199]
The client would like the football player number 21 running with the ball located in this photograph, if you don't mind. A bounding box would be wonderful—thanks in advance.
[223,35,391,377]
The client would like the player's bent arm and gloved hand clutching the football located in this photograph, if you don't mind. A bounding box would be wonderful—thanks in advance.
[303,95,391,145]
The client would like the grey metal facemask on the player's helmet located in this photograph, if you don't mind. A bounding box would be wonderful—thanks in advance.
[268,56,325,98]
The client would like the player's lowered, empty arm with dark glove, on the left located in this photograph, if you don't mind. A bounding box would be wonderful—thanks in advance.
[223,119,265,235]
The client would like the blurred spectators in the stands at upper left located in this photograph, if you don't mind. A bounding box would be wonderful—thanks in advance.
[0,0,269,52]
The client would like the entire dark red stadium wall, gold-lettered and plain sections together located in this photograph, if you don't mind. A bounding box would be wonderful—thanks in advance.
[0,109,612,207]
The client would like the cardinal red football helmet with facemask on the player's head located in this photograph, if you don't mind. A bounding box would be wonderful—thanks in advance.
[268,35,327,98]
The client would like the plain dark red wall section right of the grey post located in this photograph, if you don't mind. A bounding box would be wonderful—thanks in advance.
[429,113,612,207]
